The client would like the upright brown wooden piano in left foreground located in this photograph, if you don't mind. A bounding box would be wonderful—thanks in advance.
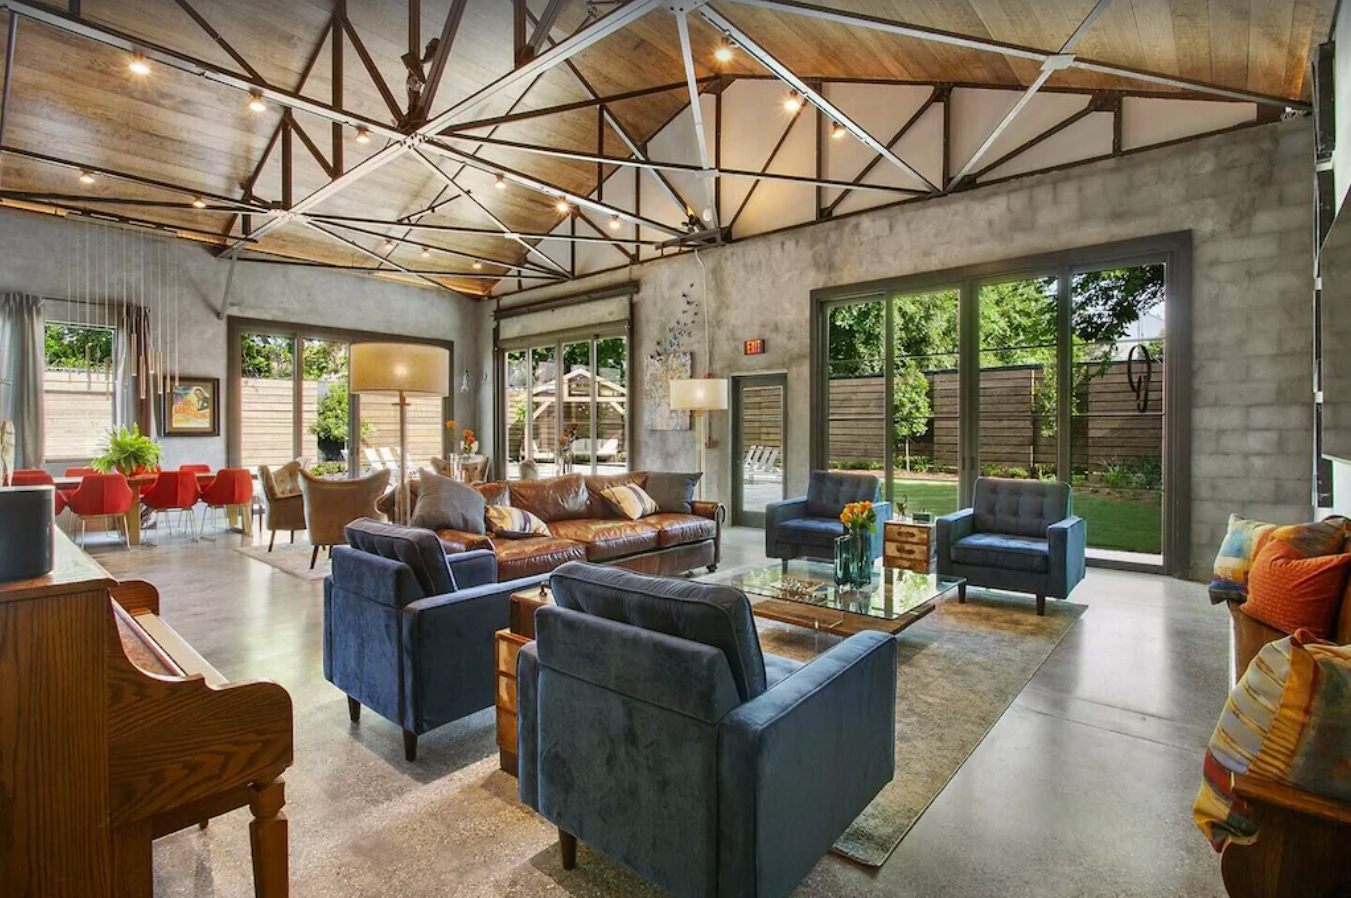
[0,532,292,898]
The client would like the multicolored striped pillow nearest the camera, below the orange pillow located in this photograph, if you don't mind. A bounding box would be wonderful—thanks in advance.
[1192,631,1351,851]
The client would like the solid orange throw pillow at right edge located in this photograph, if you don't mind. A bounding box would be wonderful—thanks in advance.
[1242,528,1351,637]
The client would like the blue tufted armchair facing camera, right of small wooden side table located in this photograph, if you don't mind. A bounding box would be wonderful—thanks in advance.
[936,477,1088,614]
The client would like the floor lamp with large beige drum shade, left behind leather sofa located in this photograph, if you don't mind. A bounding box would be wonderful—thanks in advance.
[350,343,450,525]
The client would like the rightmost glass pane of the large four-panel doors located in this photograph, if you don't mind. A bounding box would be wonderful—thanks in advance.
[1070,265,1166,555]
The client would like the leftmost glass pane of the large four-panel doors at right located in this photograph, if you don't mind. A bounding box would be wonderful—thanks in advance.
[825,301,888,471]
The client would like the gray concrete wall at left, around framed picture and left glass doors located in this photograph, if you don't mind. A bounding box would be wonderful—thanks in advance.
[0,203,492,467]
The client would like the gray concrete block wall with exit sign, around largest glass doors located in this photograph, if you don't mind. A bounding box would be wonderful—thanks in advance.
[502,119,1313,577]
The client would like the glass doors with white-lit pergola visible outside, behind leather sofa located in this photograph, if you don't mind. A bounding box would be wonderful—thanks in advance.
[499,334,628,479]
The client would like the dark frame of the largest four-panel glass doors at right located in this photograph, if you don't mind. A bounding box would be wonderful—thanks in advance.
[809,231,1192,577]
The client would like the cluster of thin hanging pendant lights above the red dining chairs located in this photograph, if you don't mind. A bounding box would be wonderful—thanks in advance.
[66,224,182,405]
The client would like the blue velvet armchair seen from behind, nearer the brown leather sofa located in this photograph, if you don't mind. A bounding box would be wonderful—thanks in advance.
[324,519,546,760]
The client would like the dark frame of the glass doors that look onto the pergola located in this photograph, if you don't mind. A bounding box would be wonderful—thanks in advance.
[493,321,634,479]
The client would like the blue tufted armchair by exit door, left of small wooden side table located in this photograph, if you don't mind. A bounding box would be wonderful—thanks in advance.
[765,471,892,562]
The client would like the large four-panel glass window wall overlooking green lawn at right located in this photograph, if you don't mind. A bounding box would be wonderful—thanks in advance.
[812,238,1189,570]
